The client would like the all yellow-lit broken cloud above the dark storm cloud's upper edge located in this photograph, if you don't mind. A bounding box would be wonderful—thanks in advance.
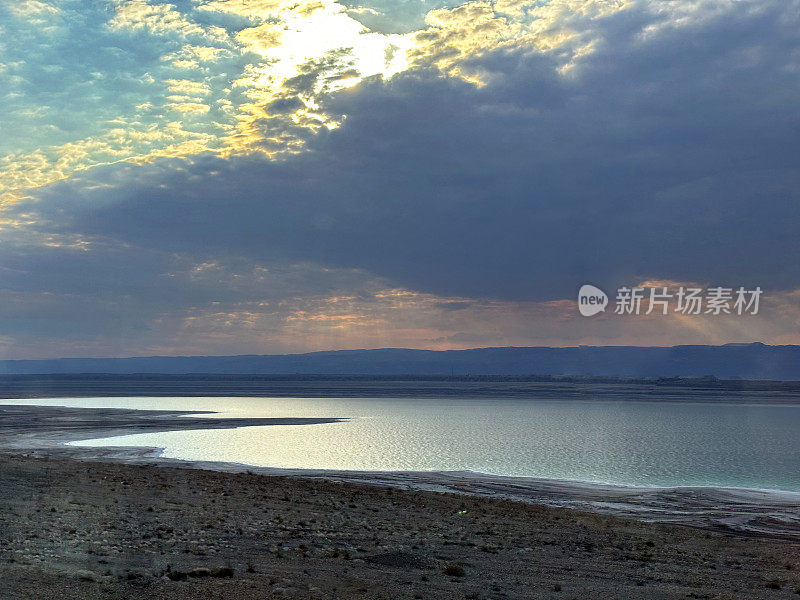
[0,0,636,205]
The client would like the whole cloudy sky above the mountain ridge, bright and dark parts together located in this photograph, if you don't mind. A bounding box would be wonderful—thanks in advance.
[0,0,800,359]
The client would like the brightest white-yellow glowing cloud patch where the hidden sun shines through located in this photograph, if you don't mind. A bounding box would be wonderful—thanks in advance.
[219,0,412,155]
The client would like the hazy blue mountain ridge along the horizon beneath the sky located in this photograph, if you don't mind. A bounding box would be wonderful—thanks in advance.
[0,343,800,381]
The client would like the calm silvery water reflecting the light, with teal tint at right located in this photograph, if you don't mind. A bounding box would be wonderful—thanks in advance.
[6,398,800,491]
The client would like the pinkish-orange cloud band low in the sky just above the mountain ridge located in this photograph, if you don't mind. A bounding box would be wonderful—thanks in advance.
[6,270,800,357]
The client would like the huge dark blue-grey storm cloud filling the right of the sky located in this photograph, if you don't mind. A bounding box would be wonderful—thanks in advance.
[6,1,800,308]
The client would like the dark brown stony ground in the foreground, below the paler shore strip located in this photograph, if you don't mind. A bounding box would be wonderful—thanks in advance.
[0,452,800,600]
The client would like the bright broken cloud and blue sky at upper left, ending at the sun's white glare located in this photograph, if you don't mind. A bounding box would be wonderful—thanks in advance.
[0,0,411,204]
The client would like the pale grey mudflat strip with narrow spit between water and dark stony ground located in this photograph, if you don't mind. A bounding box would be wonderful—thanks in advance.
[0,404,800,540]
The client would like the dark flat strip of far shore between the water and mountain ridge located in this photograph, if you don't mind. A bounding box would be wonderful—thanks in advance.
[7,373,800,405]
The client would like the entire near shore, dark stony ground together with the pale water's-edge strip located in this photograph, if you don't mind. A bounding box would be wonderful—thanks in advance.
[0,406,800,599]
